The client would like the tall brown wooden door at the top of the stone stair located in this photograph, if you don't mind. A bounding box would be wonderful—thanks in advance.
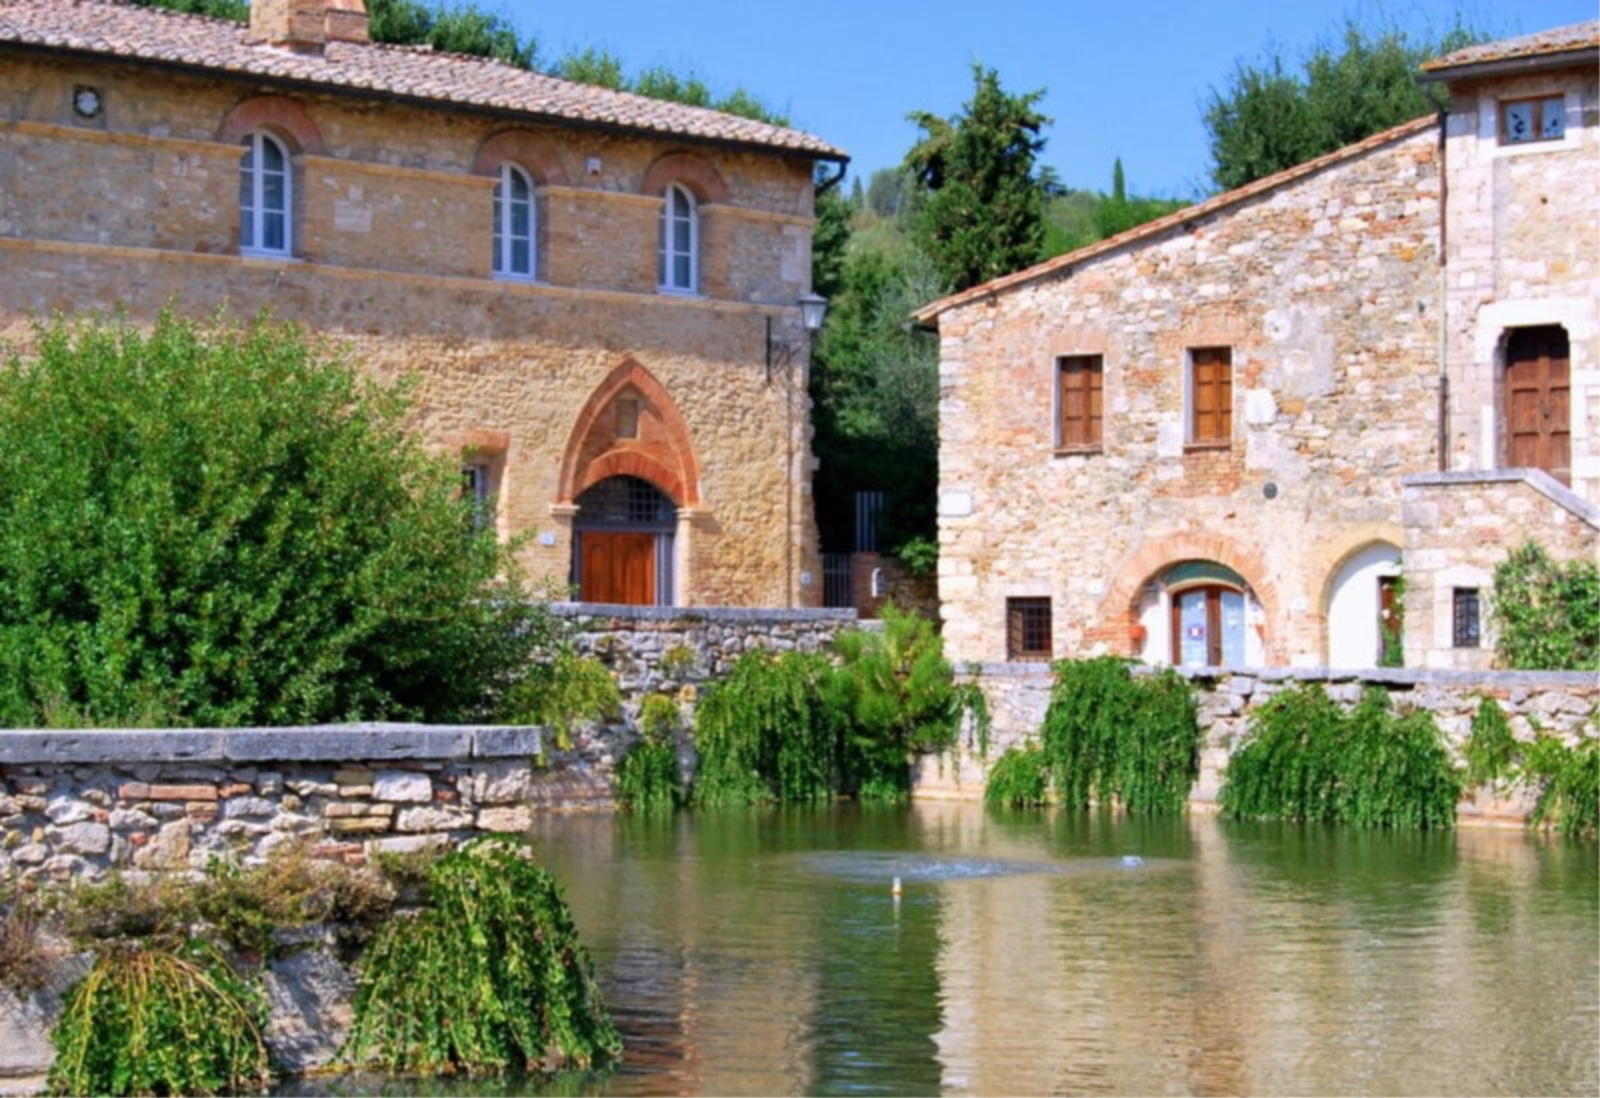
[1506,327,1573,485]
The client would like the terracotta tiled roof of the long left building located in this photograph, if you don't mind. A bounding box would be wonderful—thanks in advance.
[0,0,846,160]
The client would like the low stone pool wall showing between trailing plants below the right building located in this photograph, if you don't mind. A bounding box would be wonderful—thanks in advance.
[915,664,1600,821]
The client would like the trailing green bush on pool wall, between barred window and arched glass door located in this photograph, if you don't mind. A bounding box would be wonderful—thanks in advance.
[1043,656,1200,813]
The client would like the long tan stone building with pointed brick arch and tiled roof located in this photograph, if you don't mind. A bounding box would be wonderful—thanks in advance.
[0,0,845,607]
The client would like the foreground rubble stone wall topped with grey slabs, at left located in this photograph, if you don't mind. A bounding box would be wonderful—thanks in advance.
[0,725,544,882]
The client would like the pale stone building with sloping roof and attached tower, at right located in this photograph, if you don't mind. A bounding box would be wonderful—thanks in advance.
[918,22,1600,667]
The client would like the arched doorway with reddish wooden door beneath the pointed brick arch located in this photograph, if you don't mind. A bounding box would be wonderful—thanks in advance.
[571,475,677,607]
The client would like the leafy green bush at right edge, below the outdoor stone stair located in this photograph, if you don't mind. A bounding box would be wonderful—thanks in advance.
[1490,541,1600,671]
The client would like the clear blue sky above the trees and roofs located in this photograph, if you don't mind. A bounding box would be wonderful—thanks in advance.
[505,0,1597,198]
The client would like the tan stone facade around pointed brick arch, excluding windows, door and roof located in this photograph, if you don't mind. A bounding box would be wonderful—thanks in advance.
[0,47,821,605]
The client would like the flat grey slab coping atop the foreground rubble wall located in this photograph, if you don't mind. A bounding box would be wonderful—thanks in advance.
[0,723,541,765]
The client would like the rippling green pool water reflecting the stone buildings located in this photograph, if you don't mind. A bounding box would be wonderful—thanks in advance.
[350,803,1600,1095]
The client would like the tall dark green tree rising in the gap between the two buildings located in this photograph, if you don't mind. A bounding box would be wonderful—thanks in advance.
[906,66,1050,290]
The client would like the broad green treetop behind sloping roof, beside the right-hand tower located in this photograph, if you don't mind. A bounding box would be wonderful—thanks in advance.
[1205,21,1483,190]
